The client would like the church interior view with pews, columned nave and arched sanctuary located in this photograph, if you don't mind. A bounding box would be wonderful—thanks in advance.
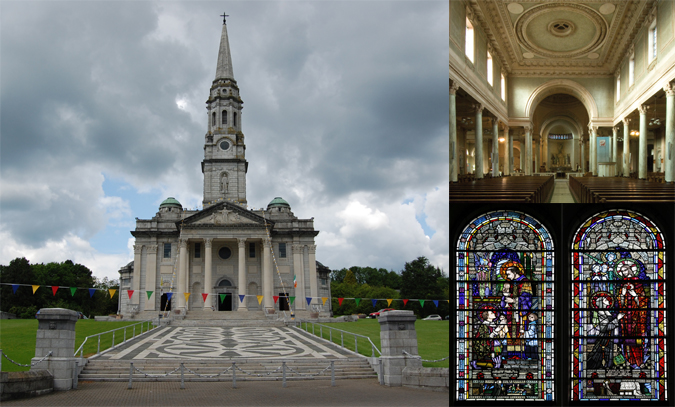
[449,0,675,204]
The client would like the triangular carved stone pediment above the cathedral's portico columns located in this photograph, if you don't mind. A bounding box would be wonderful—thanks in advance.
[181,201,274,228]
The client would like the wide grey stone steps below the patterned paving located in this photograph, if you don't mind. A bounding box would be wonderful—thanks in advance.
[79,357,377,382]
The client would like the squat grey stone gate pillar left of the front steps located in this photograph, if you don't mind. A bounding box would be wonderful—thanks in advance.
[30,308,77,390]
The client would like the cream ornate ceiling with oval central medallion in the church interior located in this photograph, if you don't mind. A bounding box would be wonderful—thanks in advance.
[468,0,655,76]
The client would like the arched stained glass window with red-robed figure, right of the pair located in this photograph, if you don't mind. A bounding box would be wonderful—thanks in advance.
[570,210,667,401]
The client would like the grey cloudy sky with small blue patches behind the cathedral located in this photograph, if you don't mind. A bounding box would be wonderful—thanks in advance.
[0,0,449,278]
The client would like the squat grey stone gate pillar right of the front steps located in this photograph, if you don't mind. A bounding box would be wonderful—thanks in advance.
[378,311,422,387]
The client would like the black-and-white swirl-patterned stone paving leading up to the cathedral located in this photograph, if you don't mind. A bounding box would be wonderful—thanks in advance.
[100,327,353,360]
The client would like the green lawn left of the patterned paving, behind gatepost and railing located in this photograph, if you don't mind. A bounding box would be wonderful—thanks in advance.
[0,319,152,372]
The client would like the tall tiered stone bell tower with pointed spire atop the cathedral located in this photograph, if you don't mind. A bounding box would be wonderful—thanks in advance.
[202,14,248,208]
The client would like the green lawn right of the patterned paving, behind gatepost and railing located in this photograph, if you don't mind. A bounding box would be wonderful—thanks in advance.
[302,319,450,367]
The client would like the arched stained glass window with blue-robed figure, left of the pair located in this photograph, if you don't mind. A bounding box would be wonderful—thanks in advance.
[456,211,555,400]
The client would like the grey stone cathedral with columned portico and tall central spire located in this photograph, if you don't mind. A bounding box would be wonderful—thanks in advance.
[119,16,330,317]
